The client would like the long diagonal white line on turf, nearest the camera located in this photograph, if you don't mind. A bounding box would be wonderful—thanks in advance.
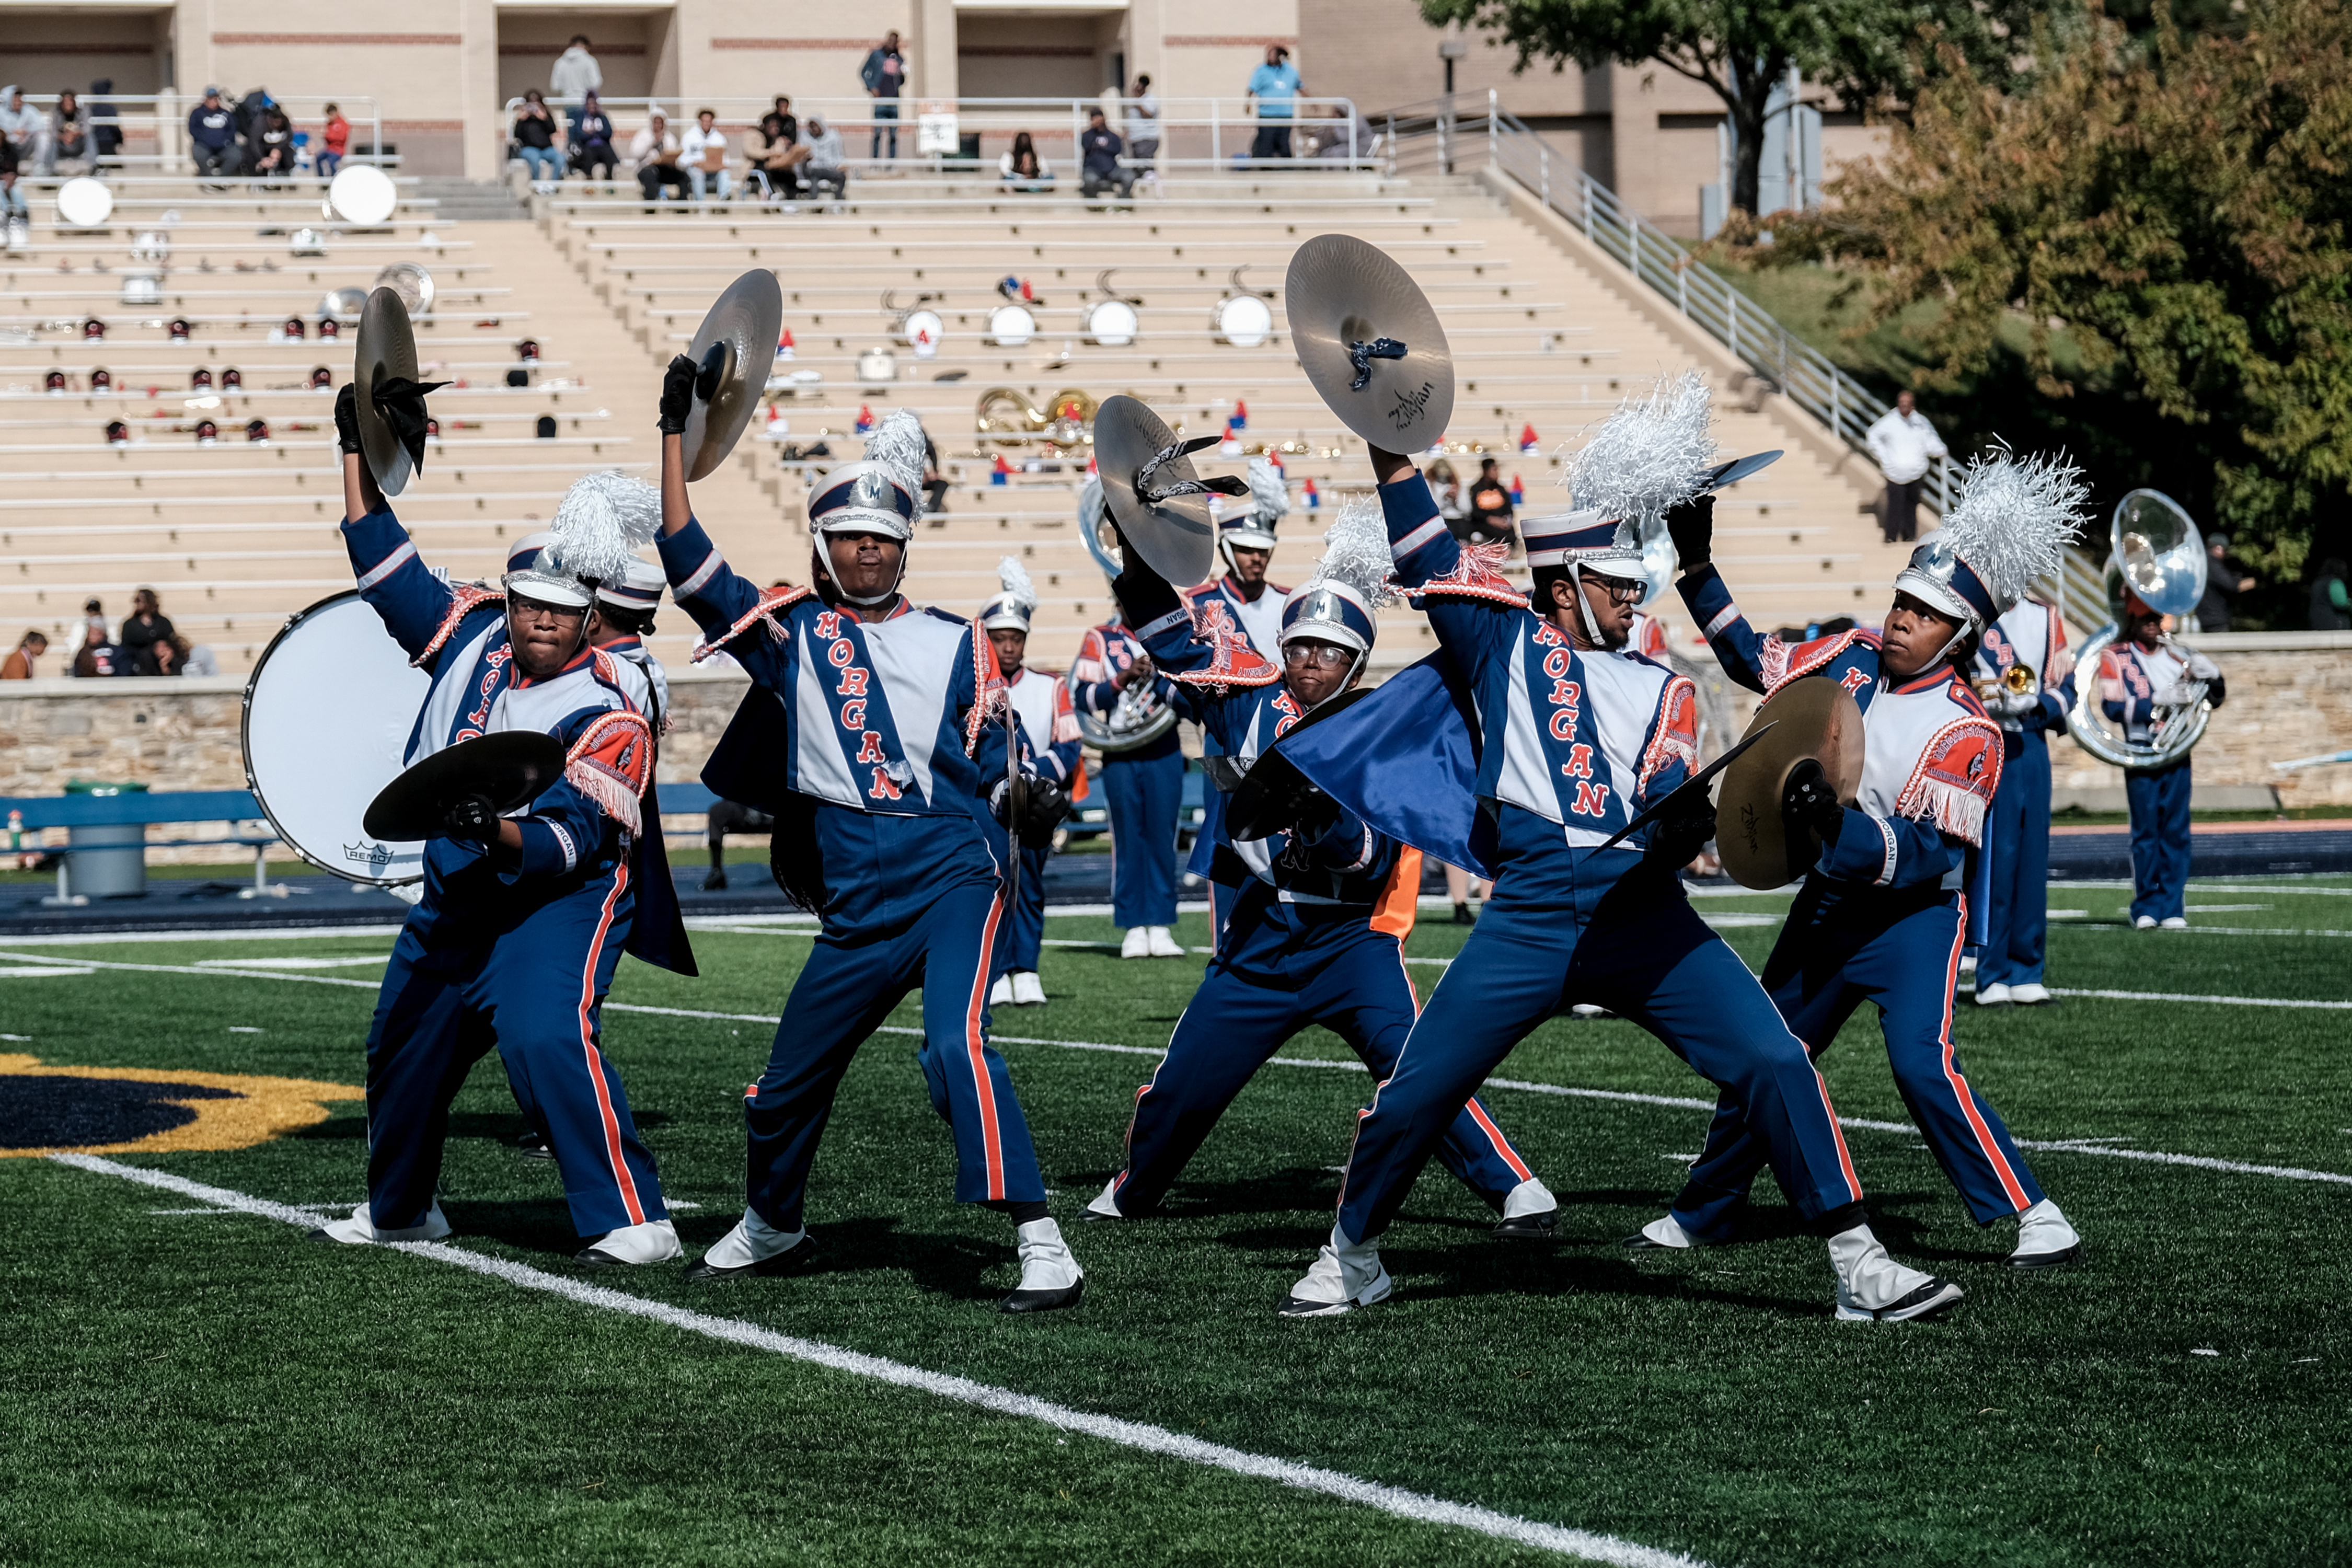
[50,1154,1705,1568]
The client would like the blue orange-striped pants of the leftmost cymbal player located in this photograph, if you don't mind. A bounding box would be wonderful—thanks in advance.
[367,865,671,1237]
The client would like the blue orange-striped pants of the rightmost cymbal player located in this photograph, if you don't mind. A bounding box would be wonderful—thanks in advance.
[1675,882,2042,1241]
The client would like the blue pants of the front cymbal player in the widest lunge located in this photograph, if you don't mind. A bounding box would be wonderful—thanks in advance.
[1339,870,1863,1241]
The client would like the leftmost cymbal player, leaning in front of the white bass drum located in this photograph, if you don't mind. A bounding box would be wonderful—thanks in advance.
[313,386,694,1265]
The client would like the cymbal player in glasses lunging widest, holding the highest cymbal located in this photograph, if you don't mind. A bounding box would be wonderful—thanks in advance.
[1282,388,1959,1319]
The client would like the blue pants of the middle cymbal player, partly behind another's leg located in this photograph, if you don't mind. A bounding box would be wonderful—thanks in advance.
[1115,884,1534,1218]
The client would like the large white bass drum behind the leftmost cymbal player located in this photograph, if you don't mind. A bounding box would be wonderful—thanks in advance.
[245,592,433,886]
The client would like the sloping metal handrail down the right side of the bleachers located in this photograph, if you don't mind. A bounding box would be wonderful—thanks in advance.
[1374,87,1952,515]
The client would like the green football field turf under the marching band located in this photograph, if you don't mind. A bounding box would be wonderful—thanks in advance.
[0,879,2352,1566]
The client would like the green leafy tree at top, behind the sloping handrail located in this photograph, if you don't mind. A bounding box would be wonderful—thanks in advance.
[1421,0,2049,214]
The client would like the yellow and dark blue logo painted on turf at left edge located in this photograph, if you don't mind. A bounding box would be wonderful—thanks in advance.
[0,1053,367,1159]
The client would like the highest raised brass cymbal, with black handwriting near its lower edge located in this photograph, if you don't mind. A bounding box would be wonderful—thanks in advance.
[1282,235,1454,452]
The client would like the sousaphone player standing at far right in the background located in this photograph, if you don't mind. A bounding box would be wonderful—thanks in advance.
[2098,592,2228,931]
